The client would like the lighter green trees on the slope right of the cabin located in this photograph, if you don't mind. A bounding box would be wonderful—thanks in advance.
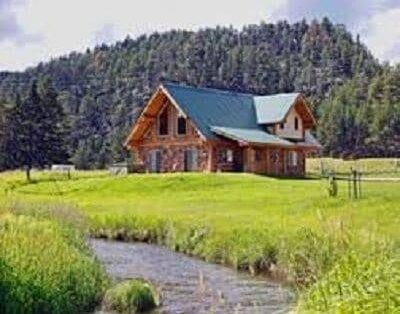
[319,65,400,157]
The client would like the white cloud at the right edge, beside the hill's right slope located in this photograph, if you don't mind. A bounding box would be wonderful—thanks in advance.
[365,8,400,62]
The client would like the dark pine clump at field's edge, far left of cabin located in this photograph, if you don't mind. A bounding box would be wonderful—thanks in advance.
[5,81,65,181]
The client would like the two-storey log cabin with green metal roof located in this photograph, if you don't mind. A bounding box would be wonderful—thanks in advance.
[125,83,321,176]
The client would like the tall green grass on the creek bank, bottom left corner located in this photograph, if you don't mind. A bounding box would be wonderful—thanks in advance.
[0,214,108,314]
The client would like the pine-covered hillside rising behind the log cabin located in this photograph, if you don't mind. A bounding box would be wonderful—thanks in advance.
[0,19,400,168]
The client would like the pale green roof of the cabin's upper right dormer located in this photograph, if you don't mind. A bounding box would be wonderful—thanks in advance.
[254,93,299,124]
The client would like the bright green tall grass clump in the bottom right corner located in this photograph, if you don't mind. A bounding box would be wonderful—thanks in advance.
[299,250,400,313]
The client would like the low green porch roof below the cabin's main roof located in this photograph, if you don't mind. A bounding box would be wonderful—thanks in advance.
[211,126,293,146]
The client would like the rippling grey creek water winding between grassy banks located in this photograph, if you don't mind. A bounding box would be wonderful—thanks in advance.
[90,240,293,314]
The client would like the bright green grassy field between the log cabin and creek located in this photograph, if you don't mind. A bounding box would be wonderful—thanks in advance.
[0,172,400,313]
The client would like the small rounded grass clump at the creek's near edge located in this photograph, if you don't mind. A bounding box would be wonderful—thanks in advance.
[103,280,159,313]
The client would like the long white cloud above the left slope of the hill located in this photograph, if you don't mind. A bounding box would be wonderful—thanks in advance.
[0,0,286,70]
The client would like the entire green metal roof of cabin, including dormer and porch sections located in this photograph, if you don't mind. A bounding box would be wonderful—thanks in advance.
[163,83,299,145]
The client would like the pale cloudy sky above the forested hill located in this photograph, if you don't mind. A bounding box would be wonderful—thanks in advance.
[0,0,400,71]
